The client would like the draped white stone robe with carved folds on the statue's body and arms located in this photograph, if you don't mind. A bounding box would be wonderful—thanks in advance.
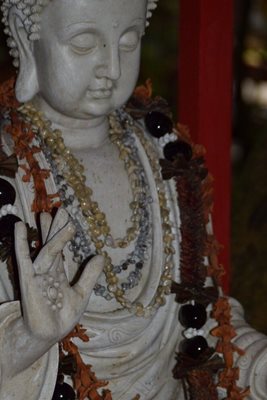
[0,123,267,400]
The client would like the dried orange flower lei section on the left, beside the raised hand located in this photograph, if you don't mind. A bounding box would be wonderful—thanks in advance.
[0,79,116,400]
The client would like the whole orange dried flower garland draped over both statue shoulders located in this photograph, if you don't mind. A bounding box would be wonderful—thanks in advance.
[0,79,249,400]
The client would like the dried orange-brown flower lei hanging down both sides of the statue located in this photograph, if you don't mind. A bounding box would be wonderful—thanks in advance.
[0,78,249,400]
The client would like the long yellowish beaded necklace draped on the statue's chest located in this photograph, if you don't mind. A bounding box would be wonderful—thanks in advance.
[20,104,175,317]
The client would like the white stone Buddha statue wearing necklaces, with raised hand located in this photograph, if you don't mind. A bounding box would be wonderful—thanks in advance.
[0,0,267,400]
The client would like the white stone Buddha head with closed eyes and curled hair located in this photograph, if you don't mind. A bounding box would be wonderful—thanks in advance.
[2,0,157,118]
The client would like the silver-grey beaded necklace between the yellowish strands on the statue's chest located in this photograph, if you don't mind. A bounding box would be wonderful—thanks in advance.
[40,109,152,300]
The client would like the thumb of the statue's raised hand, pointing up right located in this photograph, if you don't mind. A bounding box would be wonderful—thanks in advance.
[73,256,105,301]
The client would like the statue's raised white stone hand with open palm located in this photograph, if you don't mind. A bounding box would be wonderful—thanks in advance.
[15,209,104,343]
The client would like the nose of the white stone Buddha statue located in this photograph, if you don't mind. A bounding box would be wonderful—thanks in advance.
[95,46,121,81]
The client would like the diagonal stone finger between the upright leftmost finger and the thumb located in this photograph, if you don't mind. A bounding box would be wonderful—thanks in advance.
[34,222,75,274]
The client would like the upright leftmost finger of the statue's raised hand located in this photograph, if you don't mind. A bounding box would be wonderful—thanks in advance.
[15,222,34,281]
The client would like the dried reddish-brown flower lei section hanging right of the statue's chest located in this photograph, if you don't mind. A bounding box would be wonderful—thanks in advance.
[128,80,249,400]
